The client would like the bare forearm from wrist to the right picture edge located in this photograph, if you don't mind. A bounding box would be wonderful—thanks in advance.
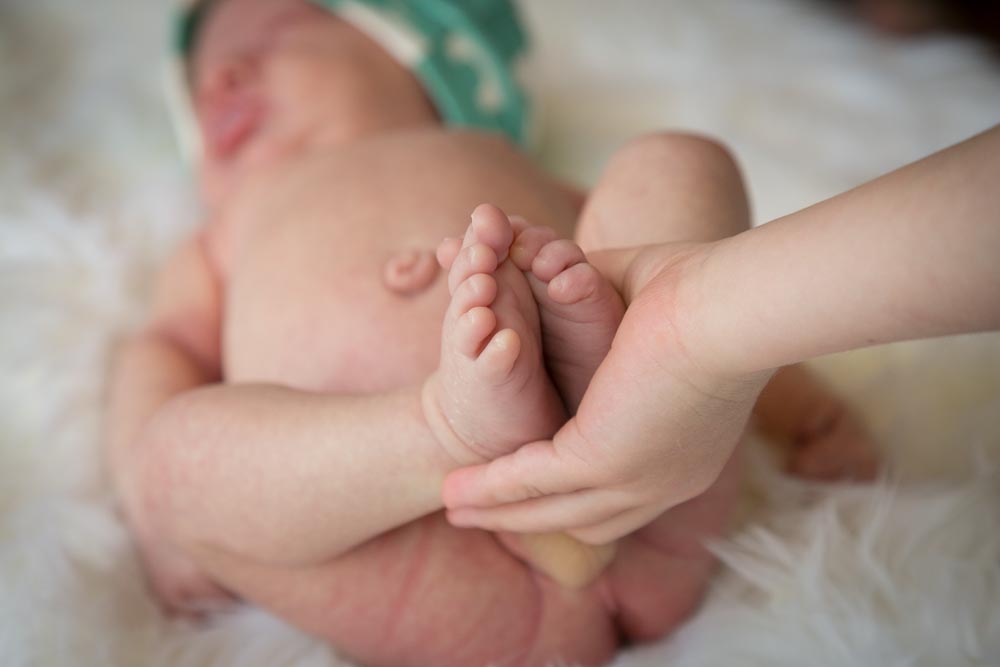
[688,128,1000,372]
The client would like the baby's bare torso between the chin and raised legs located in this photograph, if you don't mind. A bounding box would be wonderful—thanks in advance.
[210,130,575,393]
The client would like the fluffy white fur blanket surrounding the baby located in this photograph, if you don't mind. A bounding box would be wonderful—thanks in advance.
[0,0,1000,667]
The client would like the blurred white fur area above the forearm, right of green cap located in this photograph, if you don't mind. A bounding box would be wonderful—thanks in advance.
[523,0,1000,222]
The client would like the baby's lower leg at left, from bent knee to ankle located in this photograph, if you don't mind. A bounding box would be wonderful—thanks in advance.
[140,385,454,565]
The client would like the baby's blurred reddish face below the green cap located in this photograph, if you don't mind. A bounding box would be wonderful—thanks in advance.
[188,0,439,205]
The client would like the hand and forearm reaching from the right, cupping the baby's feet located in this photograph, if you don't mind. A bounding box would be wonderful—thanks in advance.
[443,127,1000,543]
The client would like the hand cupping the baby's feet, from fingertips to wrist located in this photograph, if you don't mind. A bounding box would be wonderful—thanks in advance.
[443,245,771,544]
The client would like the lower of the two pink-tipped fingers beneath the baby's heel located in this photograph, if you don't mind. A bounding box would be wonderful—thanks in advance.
[448,489,632,533]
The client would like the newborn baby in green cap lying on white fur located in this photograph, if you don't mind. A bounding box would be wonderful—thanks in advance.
[109,0,873,667]
